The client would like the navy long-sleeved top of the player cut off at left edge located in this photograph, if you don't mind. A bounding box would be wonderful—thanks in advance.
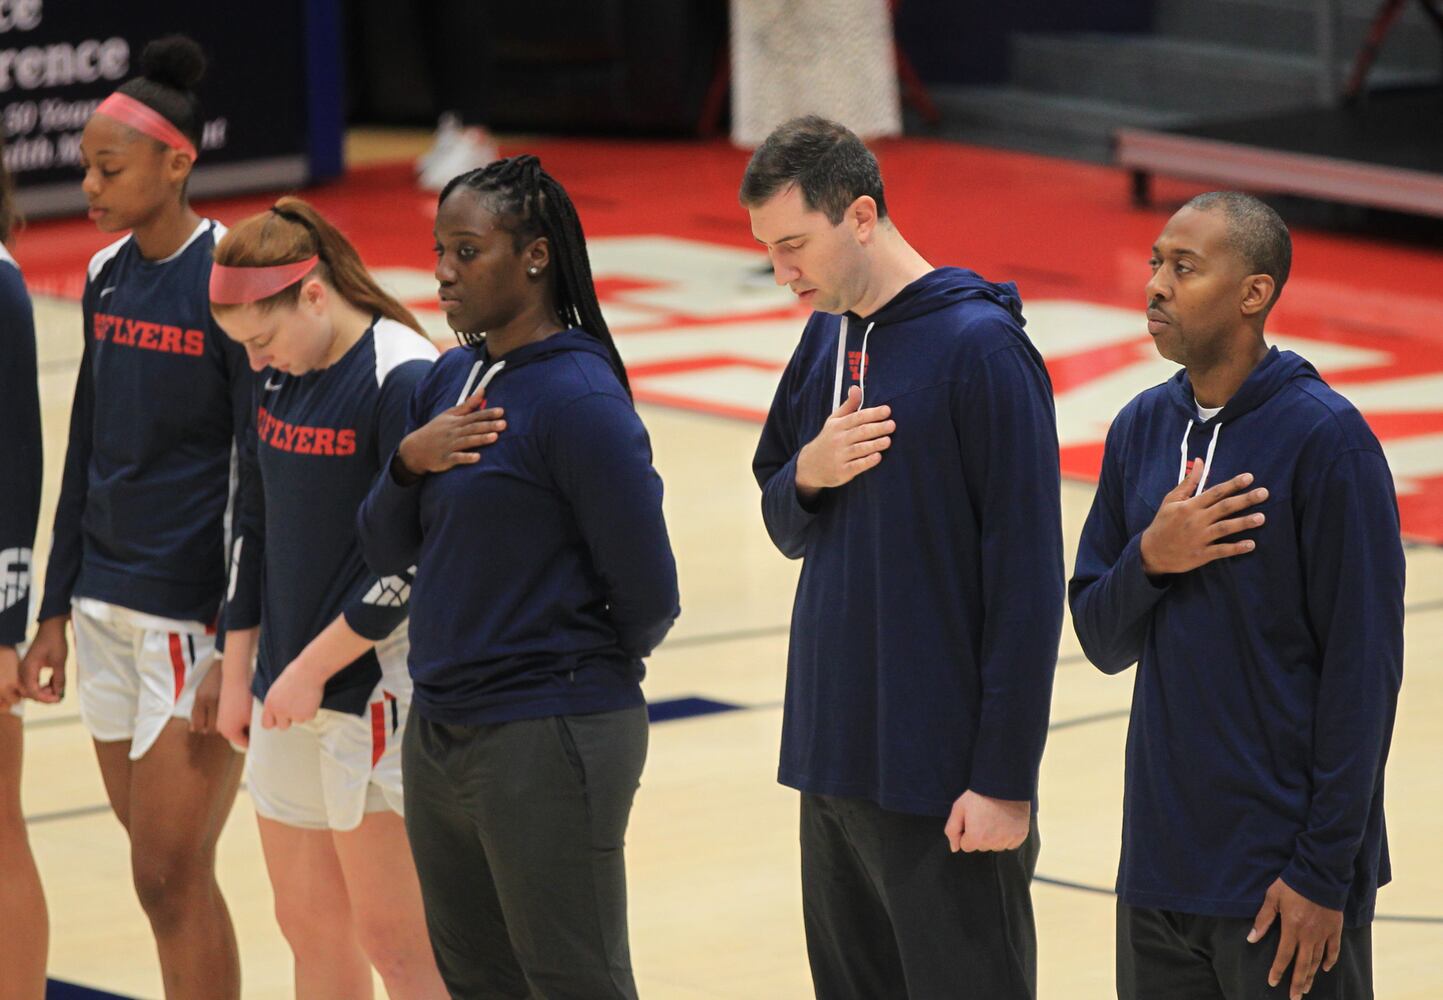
[0,244,45,646]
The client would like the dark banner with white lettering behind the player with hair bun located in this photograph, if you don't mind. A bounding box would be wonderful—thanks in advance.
[0,0,339,216]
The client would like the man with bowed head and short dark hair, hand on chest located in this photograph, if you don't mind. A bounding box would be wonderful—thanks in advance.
[740,117,1063,1000]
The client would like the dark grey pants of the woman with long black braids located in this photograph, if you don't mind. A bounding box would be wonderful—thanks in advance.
[401,707,648,1000]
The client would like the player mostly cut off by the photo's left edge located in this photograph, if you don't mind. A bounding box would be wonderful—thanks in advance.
[0,132,49,1000]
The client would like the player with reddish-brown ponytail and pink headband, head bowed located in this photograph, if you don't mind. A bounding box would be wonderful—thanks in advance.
[211,198,446,1000]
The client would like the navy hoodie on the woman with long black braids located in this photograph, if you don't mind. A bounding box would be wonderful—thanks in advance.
[359,329,680,726]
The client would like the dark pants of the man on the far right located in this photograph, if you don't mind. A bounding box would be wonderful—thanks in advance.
[1117,900,1372,1000]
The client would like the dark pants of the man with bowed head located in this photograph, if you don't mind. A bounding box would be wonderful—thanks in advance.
[801,794,1039,1000]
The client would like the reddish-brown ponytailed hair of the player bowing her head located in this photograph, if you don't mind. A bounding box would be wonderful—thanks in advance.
[211,198,427,336]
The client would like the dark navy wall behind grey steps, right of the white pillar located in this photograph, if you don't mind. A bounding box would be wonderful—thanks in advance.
[896,0,1154,84]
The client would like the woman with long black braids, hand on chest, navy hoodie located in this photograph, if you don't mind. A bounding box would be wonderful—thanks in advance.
[359,156,680,1000]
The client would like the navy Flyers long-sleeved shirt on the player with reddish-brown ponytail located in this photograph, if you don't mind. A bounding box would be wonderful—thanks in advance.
[225,319,436,716]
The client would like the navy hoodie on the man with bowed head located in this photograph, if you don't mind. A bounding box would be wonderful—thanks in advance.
[753,268,1063,817]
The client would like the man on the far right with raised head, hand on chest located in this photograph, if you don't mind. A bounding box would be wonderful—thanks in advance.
[1071,192,1404,1000]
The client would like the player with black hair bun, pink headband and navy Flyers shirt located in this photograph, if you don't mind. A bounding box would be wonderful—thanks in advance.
[20,38,250,1000]
